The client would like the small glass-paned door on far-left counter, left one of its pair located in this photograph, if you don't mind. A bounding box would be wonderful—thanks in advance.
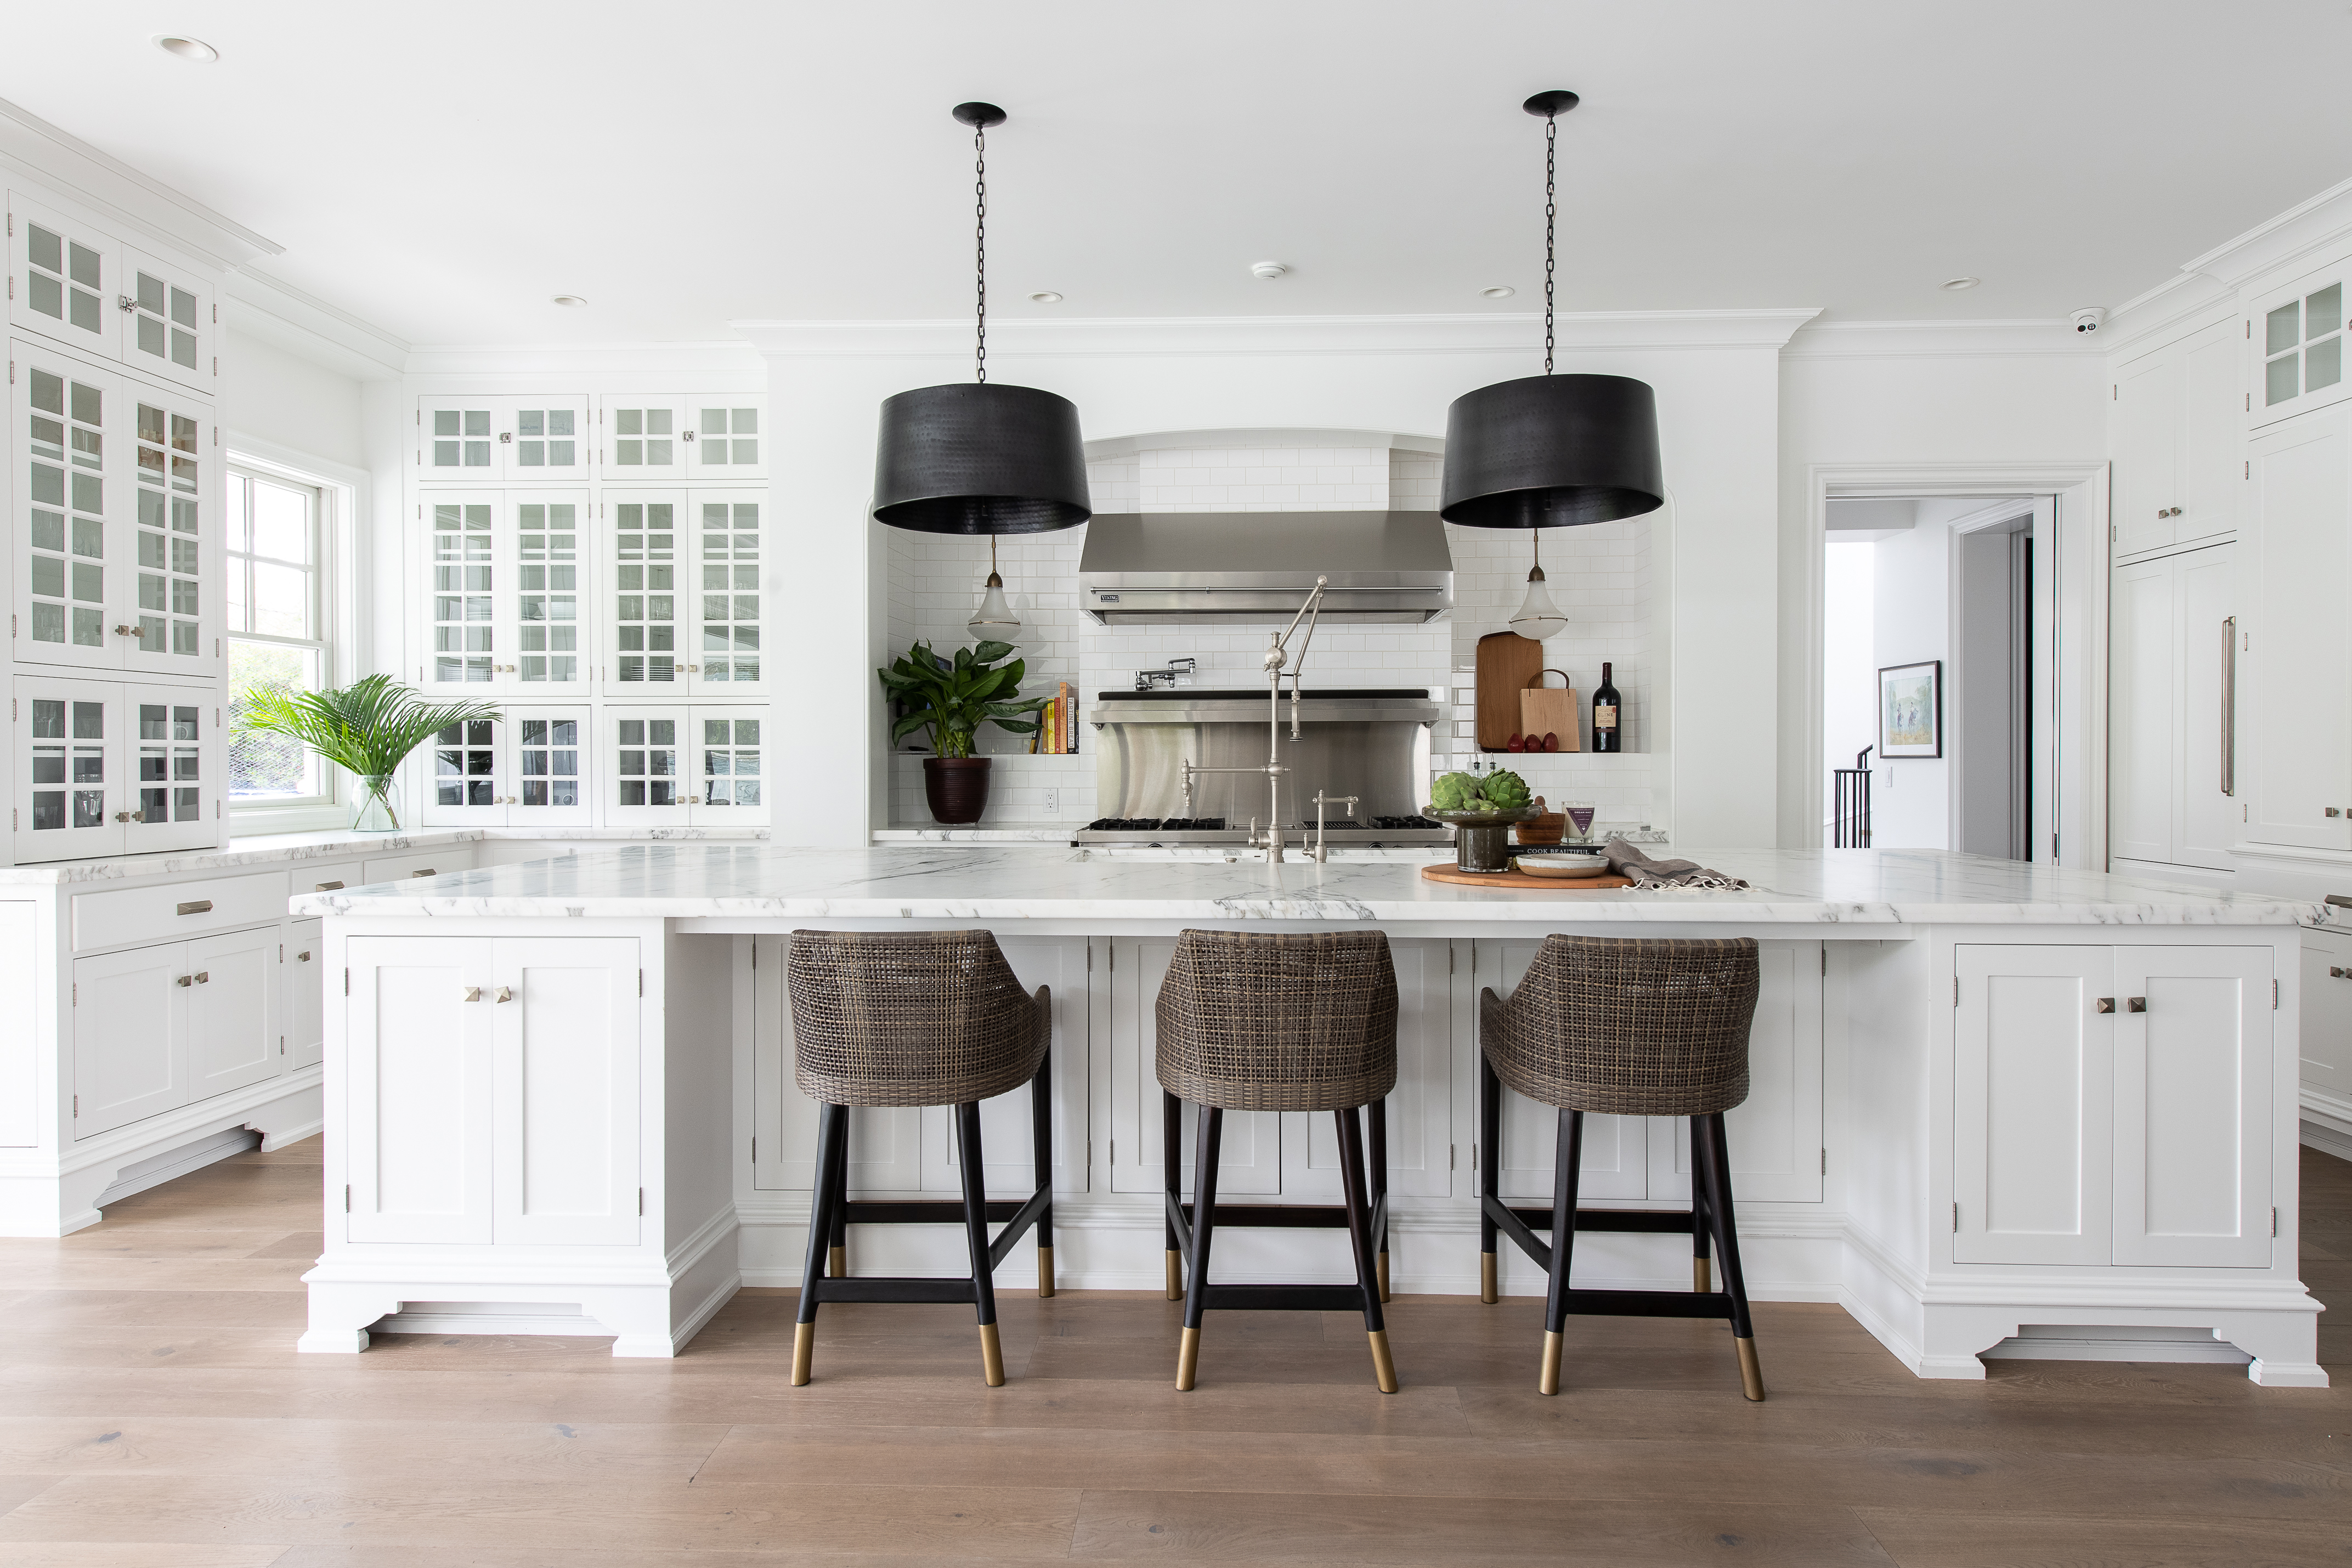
[9,680,129,865]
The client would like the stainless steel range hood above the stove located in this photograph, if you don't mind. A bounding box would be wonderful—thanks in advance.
[1077,512,1454,625]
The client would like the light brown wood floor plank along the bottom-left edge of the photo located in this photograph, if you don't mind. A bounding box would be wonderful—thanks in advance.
[0,1476,1079,1561]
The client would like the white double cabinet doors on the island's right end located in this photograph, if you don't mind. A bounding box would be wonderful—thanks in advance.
[1952,943,2274,1267]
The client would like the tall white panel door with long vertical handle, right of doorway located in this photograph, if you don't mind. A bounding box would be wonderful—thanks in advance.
[2107,545,2244,870]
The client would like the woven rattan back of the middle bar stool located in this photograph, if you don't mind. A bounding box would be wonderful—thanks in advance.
[1155,931,1397,1110]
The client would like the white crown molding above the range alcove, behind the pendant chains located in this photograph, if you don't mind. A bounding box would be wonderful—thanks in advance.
[729,310,1818,360]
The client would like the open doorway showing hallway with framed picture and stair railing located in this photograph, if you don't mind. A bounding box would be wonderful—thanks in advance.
[1820,494,2056,865]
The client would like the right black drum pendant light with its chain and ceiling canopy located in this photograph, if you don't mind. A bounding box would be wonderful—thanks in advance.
[1437,89,1665,540]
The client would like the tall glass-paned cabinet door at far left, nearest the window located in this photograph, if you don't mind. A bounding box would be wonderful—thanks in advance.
[122,381,221,675]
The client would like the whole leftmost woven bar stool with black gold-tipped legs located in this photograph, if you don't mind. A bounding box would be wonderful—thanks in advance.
[785,931,1054,1387]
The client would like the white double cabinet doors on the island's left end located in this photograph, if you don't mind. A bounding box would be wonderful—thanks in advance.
[343,936,644,1246]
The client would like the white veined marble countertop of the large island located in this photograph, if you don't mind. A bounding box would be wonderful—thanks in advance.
[294,844,2319,929]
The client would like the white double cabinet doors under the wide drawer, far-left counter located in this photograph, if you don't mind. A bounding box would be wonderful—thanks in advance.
[73,926,285,1138]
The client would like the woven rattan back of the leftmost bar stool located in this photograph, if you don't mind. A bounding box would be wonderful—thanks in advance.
[785,931,1051,1105]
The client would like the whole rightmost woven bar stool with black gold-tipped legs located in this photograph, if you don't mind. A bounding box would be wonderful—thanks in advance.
[1479,936,1764,1399]
